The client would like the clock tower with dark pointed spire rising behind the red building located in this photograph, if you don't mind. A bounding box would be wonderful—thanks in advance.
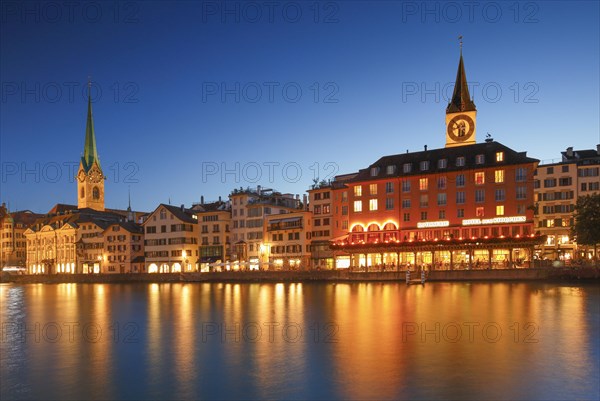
[446,36,477,148]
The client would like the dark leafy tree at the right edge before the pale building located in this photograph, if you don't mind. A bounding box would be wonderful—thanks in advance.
[571,193,600,258]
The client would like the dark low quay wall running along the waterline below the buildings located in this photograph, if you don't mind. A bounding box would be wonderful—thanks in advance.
[0,267,600,284]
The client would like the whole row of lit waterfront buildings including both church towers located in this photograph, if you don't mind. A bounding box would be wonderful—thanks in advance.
[0,52,600,274]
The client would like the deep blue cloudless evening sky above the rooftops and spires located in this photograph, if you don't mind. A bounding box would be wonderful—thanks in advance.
[0,1,600,212]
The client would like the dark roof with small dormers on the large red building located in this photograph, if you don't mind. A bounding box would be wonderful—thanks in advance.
[347,141,539,182]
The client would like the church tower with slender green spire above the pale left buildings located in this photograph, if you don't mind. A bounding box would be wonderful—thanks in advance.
[77,84,106,211]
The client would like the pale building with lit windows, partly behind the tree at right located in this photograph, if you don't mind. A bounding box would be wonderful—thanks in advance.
[534,145,600,261]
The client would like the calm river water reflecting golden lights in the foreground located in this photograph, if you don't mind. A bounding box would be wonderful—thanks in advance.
[0,283,600,400]
